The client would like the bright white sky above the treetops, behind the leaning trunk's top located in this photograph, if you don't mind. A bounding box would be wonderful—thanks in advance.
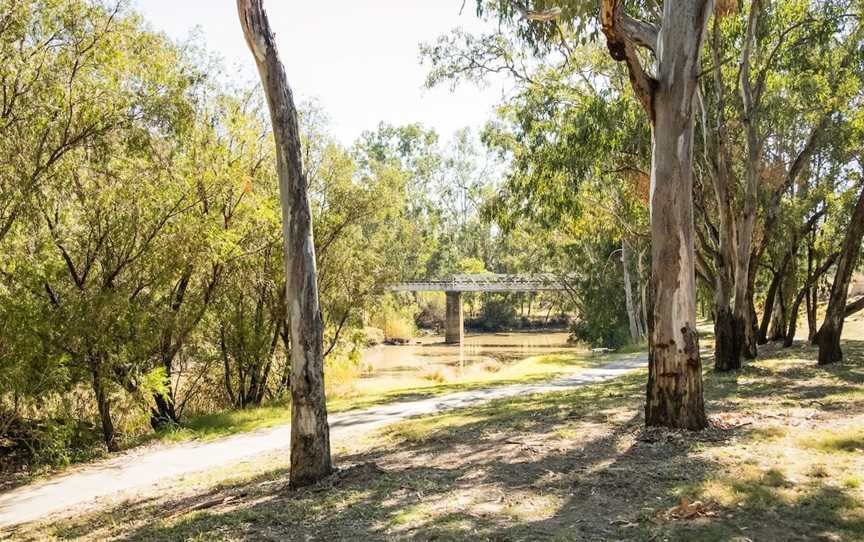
[133,0,504,145]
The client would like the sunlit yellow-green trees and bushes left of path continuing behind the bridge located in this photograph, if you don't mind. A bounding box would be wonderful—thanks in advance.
[0,0,628,478]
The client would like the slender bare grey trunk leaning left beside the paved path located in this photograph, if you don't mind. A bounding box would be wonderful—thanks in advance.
[237,0,333,486]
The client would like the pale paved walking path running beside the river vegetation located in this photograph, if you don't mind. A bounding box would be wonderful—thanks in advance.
[0,354,648,529]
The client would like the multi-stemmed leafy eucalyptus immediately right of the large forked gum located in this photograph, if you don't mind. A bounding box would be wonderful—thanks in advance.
[700,0,859,370]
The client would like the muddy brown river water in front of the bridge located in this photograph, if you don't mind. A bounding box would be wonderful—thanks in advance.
[358,331,584,390]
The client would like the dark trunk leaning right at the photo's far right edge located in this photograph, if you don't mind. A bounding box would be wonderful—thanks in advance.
[817,188,864,365]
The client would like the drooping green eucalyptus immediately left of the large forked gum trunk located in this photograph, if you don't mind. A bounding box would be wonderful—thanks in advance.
[476,46,650,346]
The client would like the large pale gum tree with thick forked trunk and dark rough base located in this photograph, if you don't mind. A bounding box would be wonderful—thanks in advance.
[601,0,714,429]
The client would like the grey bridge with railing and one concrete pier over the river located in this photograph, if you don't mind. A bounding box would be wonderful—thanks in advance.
[388,273,566,344]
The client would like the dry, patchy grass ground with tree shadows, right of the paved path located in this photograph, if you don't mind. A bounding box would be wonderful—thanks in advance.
[7,341,864,542]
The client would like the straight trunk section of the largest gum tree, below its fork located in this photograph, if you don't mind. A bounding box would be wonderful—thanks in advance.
[645,81,707,429]
